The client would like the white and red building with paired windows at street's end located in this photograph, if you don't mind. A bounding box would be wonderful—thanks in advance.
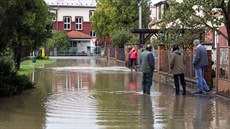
[45,0,97,55]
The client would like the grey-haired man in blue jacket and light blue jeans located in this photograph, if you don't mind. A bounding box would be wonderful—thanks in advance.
[193,39,210,94]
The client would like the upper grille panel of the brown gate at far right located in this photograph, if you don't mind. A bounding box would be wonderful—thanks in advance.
[218,48,229,79]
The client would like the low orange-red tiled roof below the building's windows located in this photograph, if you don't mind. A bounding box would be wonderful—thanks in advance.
[67,31,91,39]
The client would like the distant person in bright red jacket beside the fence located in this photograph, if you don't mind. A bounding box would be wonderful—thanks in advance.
[129,47,138,71]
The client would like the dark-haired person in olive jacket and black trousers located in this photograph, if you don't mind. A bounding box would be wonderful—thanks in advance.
[170,44,186,95]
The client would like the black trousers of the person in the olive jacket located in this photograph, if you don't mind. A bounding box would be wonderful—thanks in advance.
[173,74,186,95]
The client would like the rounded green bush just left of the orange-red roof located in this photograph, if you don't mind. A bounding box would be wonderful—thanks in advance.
[43,31,70,50]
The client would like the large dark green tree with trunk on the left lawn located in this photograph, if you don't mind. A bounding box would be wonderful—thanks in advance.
[0,0,52,69]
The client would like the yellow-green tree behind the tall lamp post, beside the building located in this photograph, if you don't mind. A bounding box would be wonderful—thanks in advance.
[91,0,150,41]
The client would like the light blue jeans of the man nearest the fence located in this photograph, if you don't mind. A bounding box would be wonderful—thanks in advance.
[195,68,209,92]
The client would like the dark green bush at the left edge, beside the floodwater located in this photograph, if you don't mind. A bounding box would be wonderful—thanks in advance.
[0,57,34,97]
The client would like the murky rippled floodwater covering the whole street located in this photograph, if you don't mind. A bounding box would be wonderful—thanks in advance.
[0,57,230,129]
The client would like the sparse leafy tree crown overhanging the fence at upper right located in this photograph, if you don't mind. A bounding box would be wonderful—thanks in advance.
[160,0,230,46]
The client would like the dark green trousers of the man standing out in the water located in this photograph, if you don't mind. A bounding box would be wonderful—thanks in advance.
[142,71,153,94]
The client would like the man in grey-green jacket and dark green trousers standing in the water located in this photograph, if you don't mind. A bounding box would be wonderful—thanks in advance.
[140,45,155,94]
